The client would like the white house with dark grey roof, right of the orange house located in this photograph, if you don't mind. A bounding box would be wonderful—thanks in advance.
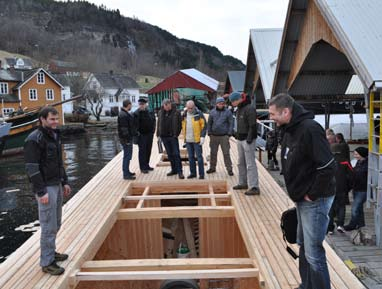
[84,71,140,115]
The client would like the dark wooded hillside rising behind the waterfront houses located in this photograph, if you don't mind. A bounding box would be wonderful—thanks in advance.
[0,0,244,80]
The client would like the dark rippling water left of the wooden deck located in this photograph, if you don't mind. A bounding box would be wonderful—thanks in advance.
[0,128,119,262]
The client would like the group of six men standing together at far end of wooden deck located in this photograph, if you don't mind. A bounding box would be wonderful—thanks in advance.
[118,92,260,195]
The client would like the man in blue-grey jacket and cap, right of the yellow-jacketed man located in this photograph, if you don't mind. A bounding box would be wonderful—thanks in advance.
[207,97,233,176]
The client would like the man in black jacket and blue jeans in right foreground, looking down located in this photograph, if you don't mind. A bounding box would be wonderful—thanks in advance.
[269,93,335,289]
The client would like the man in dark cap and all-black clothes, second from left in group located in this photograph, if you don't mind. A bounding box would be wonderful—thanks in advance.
[134,98,155,174]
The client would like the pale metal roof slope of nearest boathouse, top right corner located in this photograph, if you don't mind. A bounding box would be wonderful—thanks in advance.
[315,0,382,88]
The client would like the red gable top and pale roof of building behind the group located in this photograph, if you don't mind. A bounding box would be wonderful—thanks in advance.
[147,68,219,94]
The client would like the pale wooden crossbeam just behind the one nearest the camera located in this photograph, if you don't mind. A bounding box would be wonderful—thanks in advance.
[81,258,253,272]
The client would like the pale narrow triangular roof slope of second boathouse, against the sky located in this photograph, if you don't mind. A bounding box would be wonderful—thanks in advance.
[250,28,282,101]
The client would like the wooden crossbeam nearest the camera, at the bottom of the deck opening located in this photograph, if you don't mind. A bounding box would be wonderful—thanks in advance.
[76,268,259,281]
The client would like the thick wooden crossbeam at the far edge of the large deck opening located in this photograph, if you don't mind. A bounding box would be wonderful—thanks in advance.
[118,206,235,220]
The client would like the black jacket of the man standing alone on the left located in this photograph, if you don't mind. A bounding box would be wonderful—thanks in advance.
[24,127,68,197]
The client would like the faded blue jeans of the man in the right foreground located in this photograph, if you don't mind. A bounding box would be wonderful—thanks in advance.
[296,196,334,289]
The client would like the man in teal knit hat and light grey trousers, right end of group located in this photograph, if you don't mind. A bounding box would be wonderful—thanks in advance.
[229,92,260,196]
